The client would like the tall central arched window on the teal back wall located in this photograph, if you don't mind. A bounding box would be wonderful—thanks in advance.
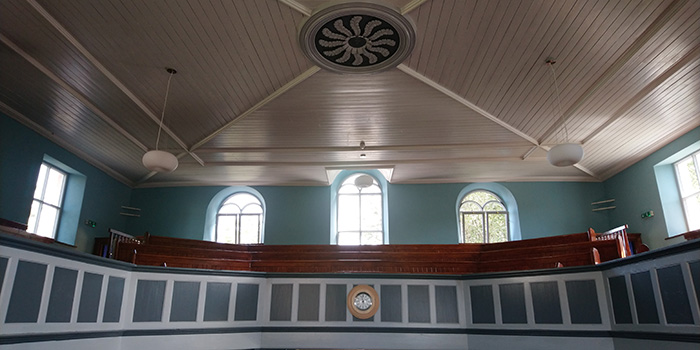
[336,173,385,245]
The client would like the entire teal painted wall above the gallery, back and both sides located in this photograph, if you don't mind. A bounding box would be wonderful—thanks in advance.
[0,110,700,251]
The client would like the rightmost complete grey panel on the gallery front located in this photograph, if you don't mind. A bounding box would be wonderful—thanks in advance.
[656,265,693,324]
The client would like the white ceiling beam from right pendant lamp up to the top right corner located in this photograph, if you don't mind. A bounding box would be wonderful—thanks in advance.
[539,0,688,143]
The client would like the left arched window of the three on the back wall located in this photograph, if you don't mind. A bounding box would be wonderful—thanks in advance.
[216,192,263,244]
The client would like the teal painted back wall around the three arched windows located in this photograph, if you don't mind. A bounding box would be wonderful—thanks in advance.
[127,182,609,244]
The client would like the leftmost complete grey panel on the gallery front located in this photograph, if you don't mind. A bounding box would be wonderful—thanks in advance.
[5,260,46,323]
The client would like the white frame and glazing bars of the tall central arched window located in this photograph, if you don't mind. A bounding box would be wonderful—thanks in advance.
[331,171,389,246]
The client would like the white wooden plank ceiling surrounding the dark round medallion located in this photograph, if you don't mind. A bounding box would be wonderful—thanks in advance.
[0,0,700,187]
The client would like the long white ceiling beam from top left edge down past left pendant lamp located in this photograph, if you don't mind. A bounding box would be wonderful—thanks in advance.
[27,0,204,165]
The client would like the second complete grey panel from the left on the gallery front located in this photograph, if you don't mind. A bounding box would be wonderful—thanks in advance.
[46,267,78,323]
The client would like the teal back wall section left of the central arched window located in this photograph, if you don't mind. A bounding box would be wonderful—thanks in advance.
[127,186,330,244]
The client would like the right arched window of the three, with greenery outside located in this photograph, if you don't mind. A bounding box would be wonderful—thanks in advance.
[459,190,510,243]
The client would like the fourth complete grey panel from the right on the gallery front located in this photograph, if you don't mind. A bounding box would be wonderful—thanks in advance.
[566,280,602,324]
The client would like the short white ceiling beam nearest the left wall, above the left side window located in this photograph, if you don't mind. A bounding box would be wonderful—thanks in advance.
[0,34,148,152]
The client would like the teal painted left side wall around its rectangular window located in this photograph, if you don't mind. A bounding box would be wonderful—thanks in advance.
[0,113,131,252]
